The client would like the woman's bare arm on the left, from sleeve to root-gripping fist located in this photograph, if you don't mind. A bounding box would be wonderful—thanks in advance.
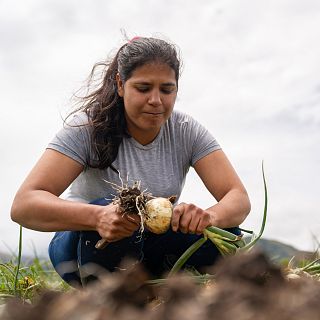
[11,149,137,241]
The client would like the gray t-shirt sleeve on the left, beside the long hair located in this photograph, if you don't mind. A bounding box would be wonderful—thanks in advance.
[47,113,90,167]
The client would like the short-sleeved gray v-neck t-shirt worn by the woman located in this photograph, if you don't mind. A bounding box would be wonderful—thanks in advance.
[48,111,220,202]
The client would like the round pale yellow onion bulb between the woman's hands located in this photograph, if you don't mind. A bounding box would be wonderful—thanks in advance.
[144,198,173,234]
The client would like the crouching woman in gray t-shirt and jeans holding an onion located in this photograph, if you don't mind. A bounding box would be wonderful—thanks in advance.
[11,37,250,282]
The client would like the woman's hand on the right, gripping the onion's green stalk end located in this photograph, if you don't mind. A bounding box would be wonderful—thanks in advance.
[171,202,214,234]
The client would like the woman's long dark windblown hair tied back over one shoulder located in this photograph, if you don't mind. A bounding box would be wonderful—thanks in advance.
[70,37,180,170]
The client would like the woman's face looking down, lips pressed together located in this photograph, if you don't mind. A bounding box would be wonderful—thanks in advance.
[117,63,177,145]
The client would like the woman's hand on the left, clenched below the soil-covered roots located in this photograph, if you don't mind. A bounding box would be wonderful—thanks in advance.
[96,204,140,242]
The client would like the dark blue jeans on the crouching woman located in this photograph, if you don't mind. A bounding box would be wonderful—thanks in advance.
[49,198,241,284]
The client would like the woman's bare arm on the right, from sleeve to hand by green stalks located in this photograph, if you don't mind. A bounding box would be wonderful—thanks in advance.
[172,150,250,233]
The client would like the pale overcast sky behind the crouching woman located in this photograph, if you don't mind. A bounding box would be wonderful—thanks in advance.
[0,0,320,254]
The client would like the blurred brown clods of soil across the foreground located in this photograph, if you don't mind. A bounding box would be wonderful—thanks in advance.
[0,252,320,320]
